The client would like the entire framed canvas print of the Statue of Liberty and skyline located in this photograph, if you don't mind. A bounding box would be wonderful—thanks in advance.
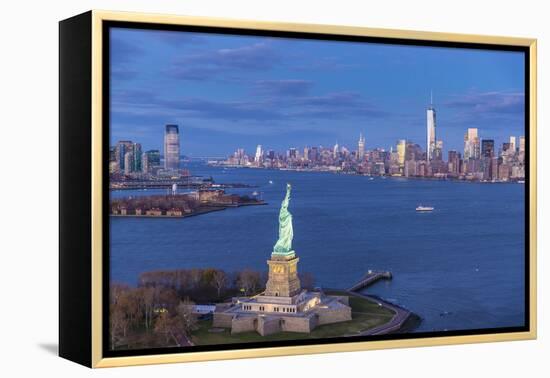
[59,11,536,367]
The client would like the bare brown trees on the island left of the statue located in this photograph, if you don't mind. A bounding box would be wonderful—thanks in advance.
[109,268,314,350]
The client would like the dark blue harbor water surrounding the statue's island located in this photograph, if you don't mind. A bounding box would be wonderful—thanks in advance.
[111,164,525,331]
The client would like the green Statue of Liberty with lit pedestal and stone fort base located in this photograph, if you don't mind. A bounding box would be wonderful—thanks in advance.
[213,184,352,336]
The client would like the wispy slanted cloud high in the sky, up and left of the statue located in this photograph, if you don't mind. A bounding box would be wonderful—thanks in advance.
[166,43,280,80]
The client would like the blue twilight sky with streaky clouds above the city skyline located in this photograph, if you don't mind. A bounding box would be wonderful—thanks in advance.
[110,28,525,157]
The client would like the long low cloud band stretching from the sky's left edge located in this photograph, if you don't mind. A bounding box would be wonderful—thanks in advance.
[112,83,388,127]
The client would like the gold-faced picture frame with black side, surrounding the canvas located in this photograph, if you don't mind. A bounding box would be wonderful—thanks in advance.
[60,10,537,368]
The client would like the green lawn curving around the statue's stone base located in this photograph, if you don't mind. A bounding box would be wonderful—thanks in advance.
[192,291,394,345]
